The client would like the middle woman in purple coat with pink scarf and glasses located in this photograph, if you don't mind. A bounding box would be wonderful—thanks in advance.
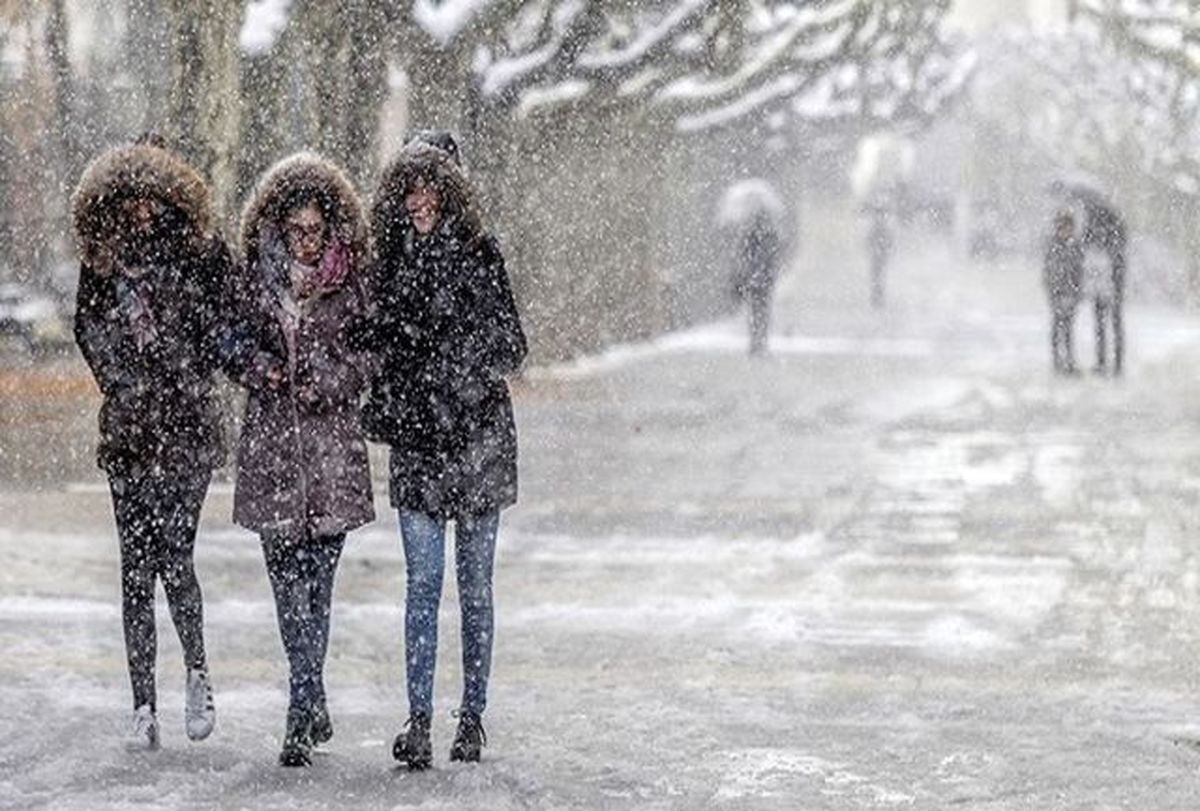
[228,154,374,765]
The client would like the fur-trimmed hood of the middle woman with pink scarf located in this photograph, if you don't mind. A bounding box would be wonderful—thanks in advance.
[240,152,368,273]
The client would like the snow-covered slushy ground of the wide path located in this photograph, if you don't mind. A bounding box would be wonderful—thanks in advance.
[7,218,1200,811]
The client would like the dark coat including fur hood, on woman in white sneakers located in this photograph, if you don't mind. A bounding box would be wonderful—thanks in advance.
[72,144,232,476]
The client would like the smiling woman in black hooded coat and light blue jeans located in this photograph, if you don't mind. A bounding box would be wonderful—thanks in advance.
[352,140,526,769]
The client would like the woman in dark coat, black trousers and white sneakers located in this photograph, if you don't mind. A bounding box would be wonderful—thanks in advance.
[71,136,232,749]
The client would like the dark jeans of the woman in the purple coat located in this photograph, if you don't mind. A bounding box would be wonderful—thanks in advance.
[263,528,346,713]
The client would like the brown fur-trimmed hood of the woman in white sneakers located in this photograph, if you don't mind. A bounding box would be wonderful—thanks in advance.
[71,144,212,275]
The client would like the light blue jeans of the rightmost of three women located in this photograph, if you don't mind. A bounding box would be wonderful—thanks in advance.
[400,510,500,715]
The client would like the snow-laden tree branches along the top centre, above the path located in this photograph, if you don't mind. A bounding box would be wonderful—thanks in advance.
[398,0,971,132]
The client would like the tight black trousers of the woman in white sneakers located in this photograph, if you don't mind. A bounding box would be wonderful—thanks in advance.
[108,470,210,709]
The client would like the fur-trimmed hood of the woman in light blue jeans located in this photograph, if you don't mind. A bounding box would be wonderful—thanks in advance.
[371,140,484,260]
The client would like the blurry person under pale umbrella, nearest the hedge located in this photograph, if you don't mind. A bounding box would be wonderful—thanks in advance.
[718,178,787,355]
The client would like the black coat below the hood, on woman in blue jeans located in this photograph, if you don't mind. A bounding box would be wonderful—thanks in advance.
[361,232,527,518]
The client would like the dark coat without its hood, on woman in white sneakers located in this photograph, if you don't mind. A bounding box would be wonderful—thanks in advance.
[74,232,233,476]
